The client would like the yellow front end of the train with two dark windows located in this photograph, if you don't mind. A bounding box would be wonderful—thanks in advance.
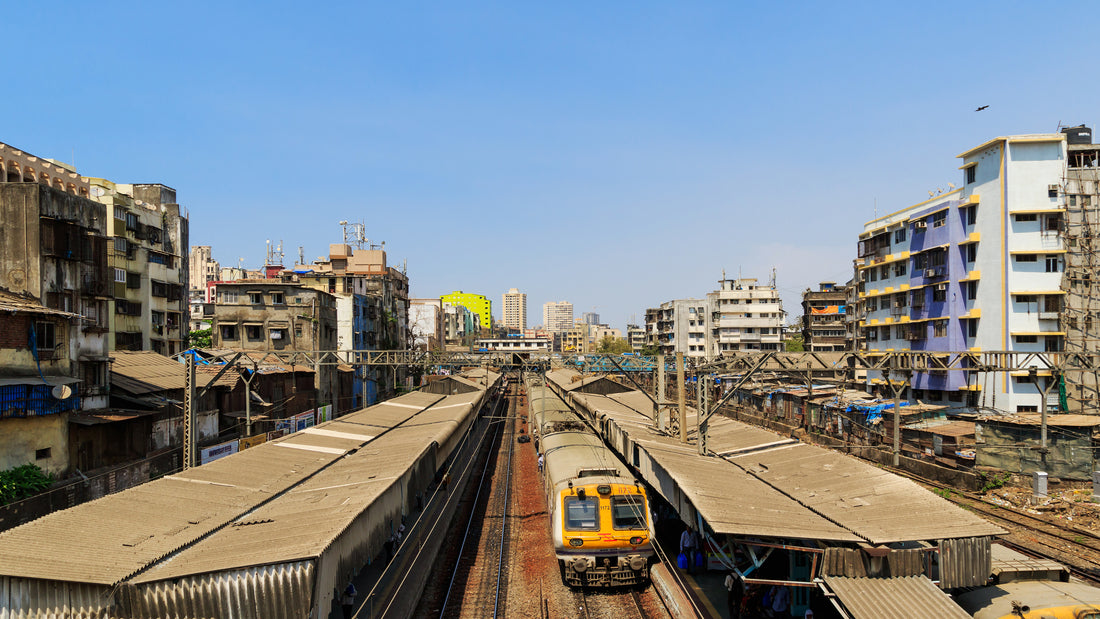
[554,477,653,587]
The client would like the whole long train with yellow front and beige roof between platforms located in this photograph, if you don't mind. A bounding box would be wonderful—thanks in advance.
[527,377,653,587]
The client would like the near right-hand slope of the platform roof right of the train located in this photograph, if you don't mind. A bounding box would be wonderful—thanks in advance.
[727,443,1004,544]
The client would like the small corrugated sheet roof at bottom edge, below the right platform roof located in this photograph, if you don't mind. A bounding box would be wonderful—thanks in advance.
[824,576,970,619]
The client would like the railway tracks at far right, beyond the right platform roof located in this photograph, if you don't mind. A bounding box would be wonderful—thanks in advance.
[895,471,1100,585]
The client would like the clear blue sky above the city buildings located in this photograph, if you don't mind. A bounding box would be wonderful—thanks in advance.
[0,2,1100,328]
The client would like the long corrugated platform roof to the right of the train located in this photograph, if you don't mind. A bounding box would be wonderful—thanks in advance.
[548,371,1004,544]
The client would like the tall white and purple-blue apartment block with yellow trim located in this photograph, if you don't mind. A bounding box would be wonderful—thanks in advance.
[857,128,1100,412]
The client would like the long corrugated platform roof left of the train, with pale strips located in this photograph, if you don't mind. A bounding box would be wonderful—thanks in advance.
[0,380,484,585]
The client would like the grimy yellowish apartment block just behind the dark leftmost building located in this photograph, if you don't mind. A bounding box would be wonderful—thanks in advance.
[88,178,191,356]
